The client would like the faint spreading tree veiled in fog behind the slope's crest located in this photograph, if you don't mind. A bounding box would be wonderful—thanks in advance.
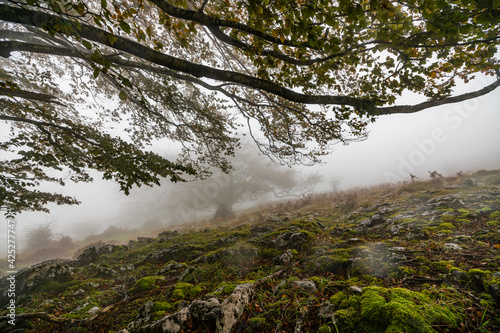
[166,148,321,220]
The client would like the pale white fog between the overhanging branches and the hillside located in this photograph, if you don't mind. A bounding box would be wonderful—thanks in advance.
[0,74,500,252]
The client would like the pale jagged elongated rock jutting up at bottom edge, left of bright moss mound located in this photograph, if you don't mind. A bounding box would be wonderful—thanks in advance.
[216,283,255,333]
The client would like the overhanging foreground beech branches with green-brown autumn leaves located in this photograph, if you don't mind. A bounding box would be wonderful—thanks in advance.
[0,0,500,214]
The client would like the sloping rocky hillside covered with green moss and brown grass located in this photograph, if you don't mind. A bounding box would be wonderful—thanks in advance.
[0,171,500,333]
